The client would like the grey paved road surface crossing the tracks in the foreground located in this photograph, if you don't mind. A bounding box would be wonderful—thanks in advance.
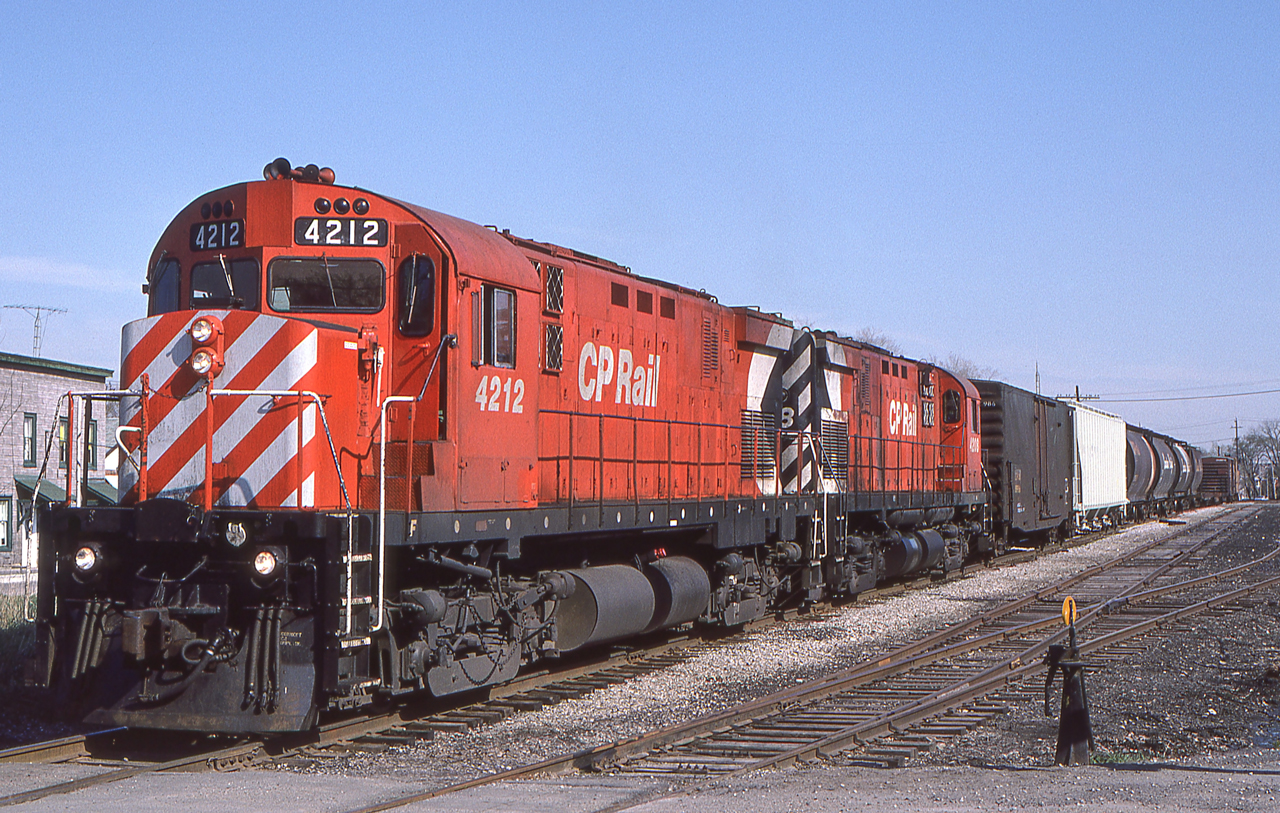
[0,749,1280,813]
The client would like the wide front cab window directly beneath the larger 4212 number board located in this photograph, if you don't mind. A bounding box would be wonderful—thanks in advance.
[268,257,385,314]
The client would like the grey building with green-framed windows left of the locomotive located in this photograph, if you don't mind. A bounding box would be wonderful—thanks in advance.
[0,352,119,566]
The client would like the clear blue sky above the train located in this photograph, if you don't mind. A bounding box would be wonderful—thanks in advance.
[0,1,1280,443]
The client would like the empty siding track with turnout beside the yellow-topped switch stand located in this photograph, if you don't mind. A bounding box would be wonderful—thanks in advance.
[325,507,1264,813]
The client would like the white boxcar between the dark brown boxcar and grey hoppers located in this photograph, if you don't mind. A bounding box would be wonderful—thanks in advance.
[1066,399,1129,527]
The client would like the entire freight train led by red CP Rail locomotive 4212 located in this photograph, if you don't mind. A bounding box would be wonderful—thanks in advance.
[33,159,1228,732]
